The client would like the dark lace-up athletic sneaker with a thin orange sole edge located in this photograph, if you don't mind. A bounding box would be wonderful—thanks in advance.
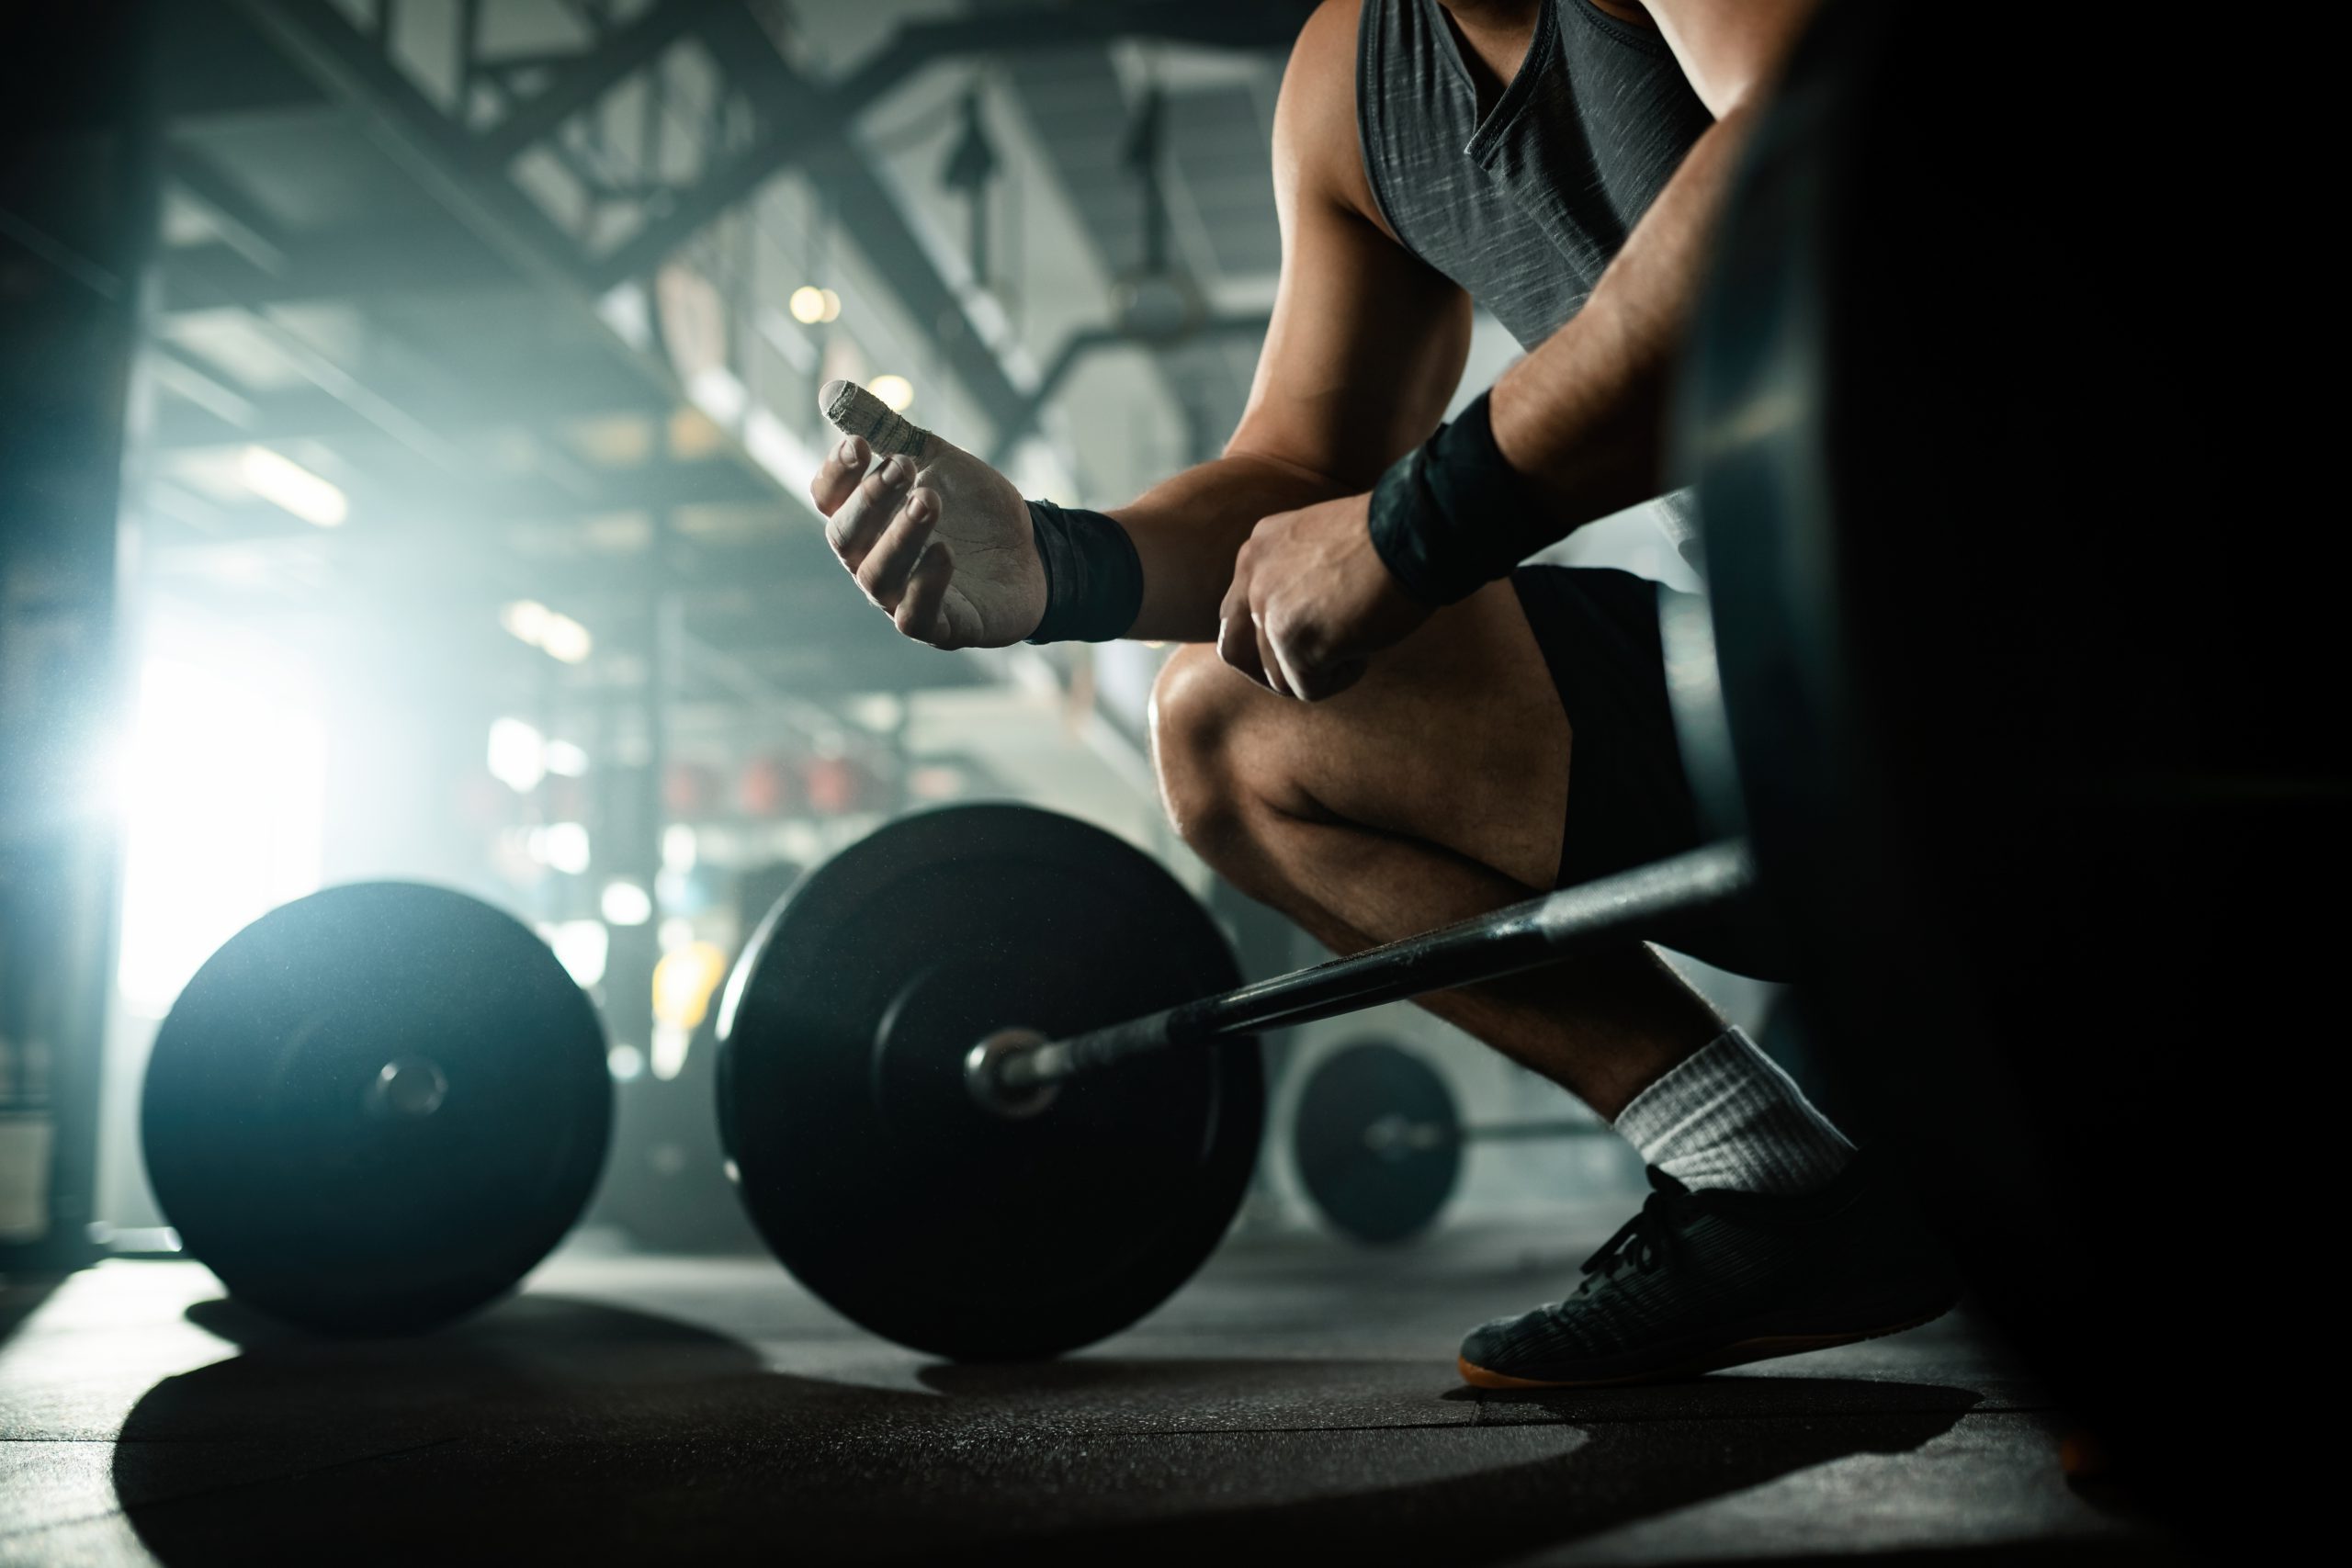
[1461,1155,1959,1389]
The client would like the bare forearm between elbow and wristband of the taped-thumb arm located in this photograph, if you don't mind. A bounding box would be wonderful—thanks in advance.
[1110,451,1350,642]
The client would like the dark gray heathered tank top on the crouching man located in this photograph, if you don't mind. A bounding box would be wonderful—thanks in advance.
[1355,0,1714,348]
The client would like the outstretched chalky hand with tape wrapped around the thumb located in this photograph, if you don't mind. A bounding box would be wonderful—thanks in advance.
[809,381,1045,649]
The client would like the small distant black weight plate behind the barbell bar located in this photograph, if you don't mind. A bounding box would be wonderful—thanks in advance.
[1291,1042,1463,1244]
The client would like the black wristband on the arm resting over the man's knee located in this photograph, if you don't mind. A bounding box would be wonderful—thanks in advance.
[1371,392,1553,609]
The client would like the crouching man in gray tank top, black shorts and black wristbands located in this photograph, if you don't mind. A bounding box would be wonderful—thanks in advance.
[811,0,1952,1387]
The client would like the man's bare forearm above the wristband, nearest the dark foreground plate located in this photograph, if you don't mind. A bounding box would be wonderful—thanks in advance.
[1488,104,1755,538]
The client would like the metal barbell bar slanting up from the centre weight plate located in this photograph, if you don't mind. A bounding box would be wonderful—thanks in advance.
[974,840,1755,1102]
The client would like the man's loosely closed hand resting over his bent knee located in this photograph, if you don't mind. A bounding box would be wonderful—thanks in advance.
[1216,496,1430,703]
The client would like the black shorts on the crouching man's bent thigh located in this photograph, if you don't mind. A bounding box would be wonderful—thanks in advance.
[1510,567,1785,980]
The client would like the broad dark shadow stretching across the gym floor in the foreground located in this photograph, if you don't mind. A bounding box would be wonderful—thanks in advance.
[113,1295,2069,1568]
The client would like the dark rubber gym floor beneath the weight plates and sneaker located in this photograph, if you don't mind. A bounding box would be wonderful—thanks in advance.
[0,1211,2178,1563]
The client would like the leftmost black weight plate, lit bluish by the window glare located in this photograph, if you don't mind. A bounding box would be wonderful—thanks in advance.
[141,882,612,1333]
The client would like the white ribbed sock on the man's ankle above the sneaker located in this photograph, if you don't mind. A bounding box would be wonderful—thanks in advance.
[1616,1027,1853,1192]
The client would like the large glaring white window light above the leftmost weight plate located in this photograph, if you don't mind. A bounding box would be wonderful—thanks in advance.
[115,659,327,1018]
